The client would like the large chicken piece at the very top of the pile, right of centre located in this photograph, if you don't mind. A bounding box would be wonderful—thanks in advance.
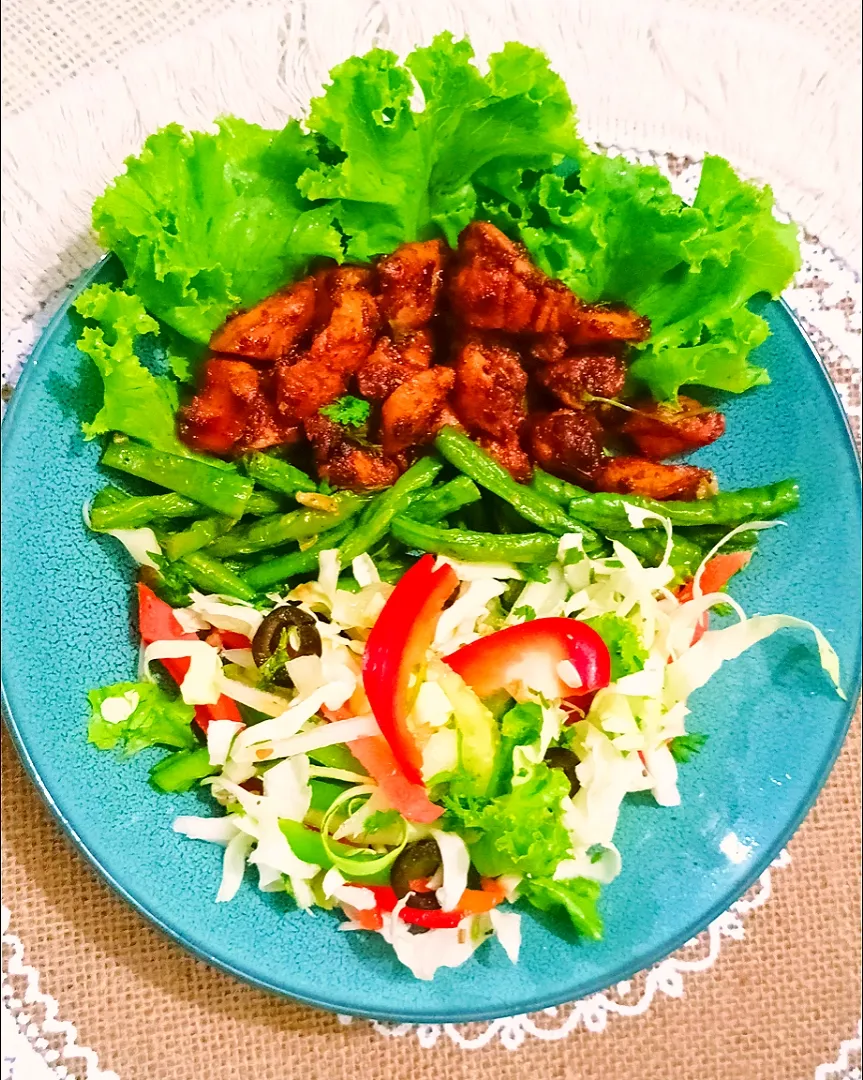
[449,221,581,334]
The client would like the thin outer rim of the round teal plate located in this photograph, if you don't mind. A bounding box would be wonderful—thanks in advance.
[0,254,863,1024]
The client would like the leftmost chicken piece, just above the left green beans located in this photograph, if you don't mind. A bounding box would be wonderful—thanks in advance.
[179,356,299,455]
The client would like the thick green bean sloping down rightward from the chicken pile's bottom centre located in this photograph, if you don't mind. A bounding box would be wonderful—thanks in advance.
[435,428,602,554]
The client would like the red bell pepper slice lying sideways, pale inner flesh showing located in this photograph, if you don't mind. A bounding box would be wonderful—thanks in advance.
[444,619,611,700]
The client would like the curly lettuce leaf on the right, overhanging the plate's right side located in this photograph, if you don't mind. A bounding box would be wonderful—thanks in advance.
[478,152,800,401]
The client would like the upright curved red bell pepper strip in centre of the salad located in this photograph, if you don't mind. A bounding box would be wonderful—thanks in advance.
[363,555,458,784]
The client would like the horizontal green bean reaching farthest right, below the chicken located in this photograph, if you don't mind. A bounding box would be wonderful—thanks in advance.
[569,480,800,531]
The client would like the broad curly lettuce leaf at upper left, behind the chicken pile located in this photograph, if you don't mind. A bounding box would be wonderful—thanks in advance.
[93,118,313,342]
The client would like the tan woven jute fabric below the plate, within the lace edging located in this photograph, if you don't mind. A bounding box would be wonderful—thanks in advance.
[2,712,861,1080]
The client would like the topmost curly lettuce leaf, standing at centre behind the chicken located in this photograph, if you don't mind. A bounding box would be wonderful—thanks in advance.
[299,32,581,260]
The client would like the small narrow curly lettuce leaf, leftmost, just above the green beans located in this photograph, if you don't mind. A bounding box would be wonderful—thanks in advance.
[75,285,186,454]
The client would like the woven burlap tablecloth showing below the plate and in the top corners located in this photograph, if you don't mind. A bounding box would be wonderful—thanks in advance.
[0,0,861,1080]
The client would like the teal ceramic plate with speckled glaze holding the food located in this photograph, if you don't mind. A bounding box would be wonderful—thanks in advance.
[3,254,861,1022]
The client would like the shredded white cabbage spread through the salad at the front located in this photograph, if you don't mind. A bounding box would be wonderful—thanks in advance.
[150,518,841,978]
